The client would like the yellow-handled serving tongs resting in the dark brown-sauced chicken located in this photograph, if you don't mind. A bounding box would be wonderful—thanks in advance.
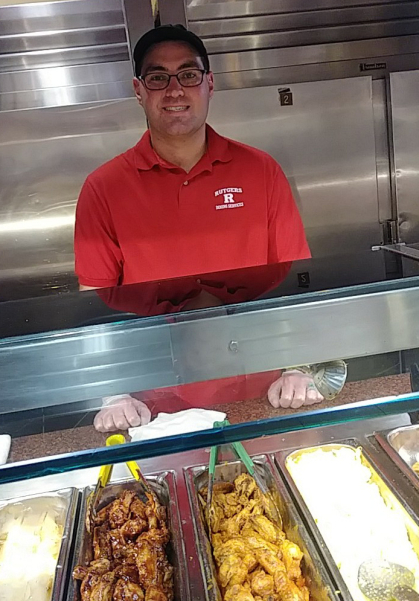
[86,434,159,534]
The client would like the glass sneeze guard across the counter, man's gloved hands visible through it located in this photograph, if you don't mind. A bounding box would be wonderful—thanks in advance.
[0,253,419,481]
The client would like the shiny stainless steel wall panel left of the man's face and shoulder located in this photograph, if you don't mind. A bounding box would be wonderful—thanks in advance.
[0,98,146,288]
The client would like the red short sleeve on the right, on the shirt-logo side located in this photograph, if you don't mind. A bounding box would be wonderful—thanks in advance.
[268,164,311,263]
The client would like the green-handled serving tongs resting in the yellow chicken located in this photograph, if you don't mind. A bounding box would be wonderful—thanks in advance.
[206,419,282,527]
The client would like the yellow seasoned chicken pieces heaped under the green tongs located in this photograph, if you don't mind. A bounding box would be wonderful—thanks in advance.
[201,474,309,601]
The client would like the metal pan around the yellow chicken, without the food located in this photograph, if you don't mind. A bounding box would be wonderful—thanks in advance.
[185,455,340,601]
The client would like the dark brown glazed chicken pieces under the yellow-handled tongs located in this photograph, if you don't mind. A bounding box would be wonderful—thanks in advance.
[73,490,173,601]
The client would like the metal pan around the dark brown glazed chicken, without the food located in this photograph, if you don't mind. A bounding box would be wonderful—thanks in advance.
[67,472,189,601]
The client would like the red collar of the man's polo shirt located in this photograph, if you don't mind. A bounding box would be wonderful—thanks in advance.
[133,125,232,171]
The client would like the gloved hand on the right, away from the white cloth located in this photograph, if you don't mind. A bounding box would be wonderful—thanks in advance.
[268,369,324,409]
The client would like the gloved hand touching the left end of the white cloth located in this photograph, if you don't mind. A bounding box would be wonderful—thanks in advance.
[93,394,151,432]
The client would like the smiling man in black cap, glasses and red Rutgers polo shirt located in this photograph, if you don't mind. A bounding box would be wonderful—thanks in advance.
[75,26,322,430]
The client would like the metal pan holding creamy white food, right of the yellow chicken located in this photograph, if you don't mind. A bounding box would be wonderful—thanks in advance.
[275,439,419,601]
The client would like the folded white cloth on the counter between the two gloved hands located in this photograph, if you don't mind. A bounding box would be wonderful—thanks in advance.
[128,409,226,441]
